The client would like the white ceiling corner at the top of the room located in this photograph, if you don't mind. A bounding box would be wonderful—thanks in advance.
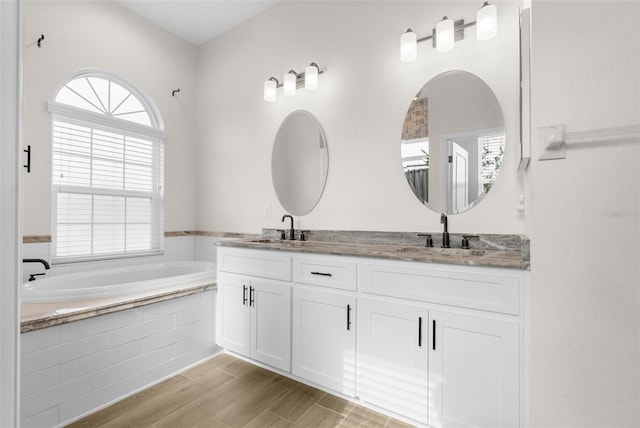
[115,0,279,46]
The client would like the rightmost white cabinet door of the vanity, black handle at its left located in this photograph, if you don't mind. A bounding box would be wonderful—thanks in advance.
[429,311,520,427]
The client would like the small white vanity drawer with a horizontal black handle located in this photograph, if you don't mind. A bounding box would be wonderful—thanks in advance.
[293,256,357,291]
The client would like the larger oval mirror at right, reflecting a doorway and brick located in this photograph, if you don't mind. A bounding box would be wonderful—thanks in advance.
[401,71,505,214]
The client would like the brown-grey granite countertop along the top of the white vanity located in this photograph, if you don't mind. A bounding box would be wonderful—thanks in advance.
[218,232,529,269]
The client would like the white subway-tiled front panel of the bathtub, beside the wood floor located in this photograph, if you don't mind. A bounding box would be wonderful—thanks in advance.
[21,287,219,427]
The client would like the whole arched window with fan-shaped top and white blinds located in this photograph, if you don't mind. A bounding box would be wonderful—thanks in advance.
[50,72,164,262]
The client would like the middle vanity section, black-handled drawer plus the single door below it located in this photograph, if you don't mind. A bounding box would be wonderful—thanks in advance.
[291,256,357,397]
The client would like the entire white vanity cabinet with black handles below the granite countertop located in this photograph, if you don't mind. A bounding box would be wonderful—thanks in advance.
[218,247,528,428]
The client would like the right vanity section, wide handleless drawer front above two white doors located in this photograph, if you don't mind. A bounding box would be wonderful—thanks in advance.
[358,262,525,427]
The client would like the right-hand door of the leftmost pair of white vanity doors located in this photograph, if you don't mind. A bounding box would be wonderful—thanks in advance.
[249,278,291,371]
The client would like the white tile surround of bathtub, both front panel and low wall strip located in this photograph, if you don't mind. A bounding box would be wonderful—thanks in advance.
[21,235,224,427]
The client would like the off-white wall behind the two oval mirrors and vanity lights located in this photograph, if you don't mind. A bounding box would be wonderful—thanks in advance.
[196,1,524,233]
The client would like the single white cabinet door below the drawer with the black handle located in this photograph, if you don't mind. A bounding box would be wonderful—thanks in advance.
[292,286,356,397]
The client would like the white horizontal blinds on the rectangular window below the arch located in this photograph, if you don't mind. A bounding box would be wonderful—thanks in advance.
[52,116,164,262]
